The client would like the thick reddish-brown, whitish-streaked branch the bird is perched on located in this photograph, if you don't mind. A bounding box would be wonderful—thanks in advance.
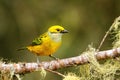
[0,48,120,74]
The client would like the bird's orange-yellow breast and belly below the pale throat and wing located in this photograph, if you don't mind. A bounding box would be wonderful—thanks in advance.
[27,40,61,56]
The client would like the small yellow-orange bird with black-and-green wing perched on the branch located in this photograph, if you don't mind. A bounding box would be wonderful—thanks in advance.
[18,25,68,62]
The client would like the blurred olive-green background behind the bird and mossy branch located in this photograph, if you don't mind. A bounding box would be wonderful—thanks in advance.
[0,0,120,80]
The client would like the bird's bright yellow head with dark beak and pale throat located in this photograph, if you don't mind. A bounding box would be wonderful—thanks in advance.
[48,25,68,41]
